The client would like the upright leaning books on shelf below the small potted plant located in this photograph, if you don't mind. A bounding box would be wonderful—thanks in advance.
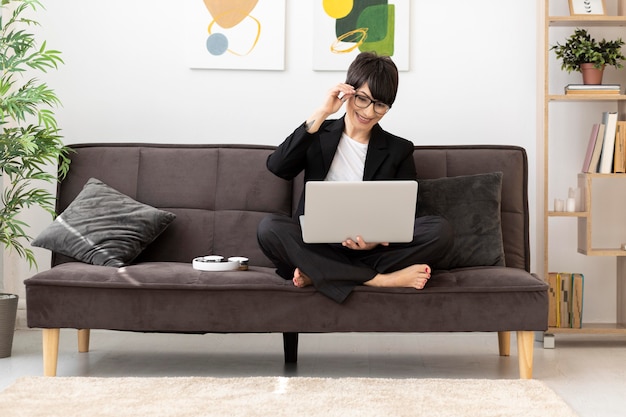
[582,112,626,174]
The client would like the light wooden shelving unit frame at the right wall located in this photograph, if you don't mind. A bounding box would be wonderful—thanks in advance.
[542,0,626,347]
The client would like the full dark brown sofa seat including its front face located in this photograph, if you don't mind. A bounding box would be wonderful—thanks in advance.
[26,262,548,333]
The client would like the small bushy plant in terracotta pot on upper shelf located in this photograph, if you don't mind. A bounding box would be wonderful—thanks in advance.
[550,29,626,84]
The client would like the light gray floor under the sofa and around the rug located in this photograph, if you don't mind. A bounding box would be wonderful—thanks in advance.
[0,330,626,417]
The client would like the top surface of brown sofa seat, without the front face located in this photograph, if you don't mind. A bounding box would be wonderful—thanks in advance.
[26,262,545,295]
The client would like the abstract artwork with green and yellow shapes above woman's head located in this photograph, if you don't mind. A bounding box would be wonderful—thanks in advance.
[313,0,409,71]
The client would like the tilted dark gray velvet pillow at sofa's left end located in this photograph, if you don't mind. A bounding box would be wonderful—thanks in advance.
[32,178,176,267]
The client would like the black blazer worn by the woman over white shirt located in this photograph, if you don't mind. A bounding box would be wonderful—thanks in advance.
[267,117,417,215]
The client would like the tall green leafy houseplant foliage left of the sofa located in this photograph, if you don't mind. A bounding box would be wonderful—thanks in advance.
[0,0,69,267]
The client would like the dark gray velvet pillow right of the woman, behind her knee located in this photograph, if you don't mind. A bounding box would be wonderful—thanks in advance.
[417,172,504,269]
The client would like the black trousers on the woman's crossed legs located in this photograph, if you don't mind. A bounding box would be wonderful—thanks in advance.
[257,214,452,303]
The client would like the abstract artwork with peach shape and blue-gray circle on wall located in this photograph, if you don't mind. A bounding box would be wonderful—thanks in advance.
[183,0,285,70]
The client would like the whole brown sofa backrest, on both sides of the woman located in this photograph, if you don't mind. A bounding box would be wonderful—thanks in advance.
[52,143,530,270]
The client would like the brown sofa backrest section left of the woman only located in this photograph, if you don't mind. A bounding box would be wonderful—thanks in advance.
[52,143,293,266]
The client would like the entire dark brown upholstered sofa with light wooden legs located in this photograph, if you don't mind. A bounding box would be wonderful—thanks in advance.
[25,144,548,378]
